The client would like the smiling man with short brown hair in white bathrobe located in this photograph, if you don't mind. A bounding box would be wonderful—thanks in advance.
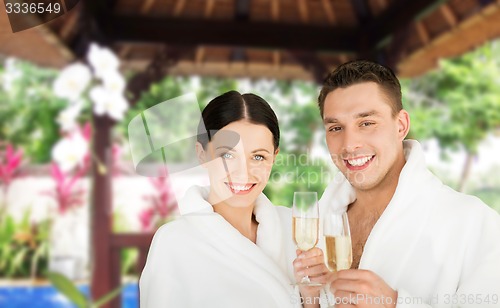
[294,61,500,308]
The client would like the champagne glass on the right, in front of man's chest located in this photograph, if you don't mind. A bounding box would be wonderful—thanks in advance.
[323,211,352,272]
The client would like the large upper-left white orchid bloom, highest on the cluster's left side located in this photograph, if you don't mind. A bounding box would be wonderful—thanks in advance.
[53,63,92,101]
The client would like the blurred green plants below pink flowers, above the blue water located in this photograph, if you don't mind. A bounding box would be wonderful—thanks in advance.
[0,211,50,278]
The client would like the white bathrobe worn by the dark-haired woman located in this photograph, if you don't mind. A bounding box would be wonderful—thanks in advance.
[140,187,299,308]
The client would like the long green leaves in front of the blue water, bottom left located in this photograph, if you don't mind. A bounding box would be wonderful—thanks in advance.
[47,272,124,308]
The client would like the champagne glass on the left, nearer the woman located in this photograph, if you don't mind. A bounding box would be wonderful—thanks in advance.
[292,191,321,286]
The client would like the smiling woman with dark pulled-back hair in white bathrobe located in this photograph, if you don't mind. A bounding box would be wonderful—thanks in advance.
[140,91,297,308]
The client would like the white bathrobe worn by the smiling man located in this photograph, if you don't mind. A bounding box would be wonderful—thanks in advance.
[320,140,500,308]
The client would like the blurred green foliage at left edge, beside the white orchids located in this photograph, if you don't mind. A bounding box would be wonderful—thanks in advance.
[0,61,66,163]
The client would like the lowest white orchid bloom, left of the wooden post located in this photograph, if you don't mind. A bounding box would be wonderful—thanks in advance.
[52,133,89,172]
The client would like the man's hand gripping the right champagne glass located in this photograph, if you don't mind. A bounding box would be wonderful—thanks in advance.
[330,269,398,308]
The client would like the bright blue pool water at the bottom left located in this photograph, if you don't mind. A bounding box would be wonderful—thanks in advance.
[0,284,139,308]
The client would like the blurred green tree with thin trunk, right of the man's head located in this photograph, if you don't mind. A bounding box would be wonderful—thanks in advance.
[403,41,500,191]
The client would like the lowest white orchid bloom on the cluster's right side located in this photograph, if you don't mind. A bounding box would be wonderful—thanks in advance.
[90,86,128,120]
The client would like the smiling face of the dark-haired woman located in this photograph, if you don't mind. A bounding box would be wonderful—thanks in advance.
[197,120,278,207]
